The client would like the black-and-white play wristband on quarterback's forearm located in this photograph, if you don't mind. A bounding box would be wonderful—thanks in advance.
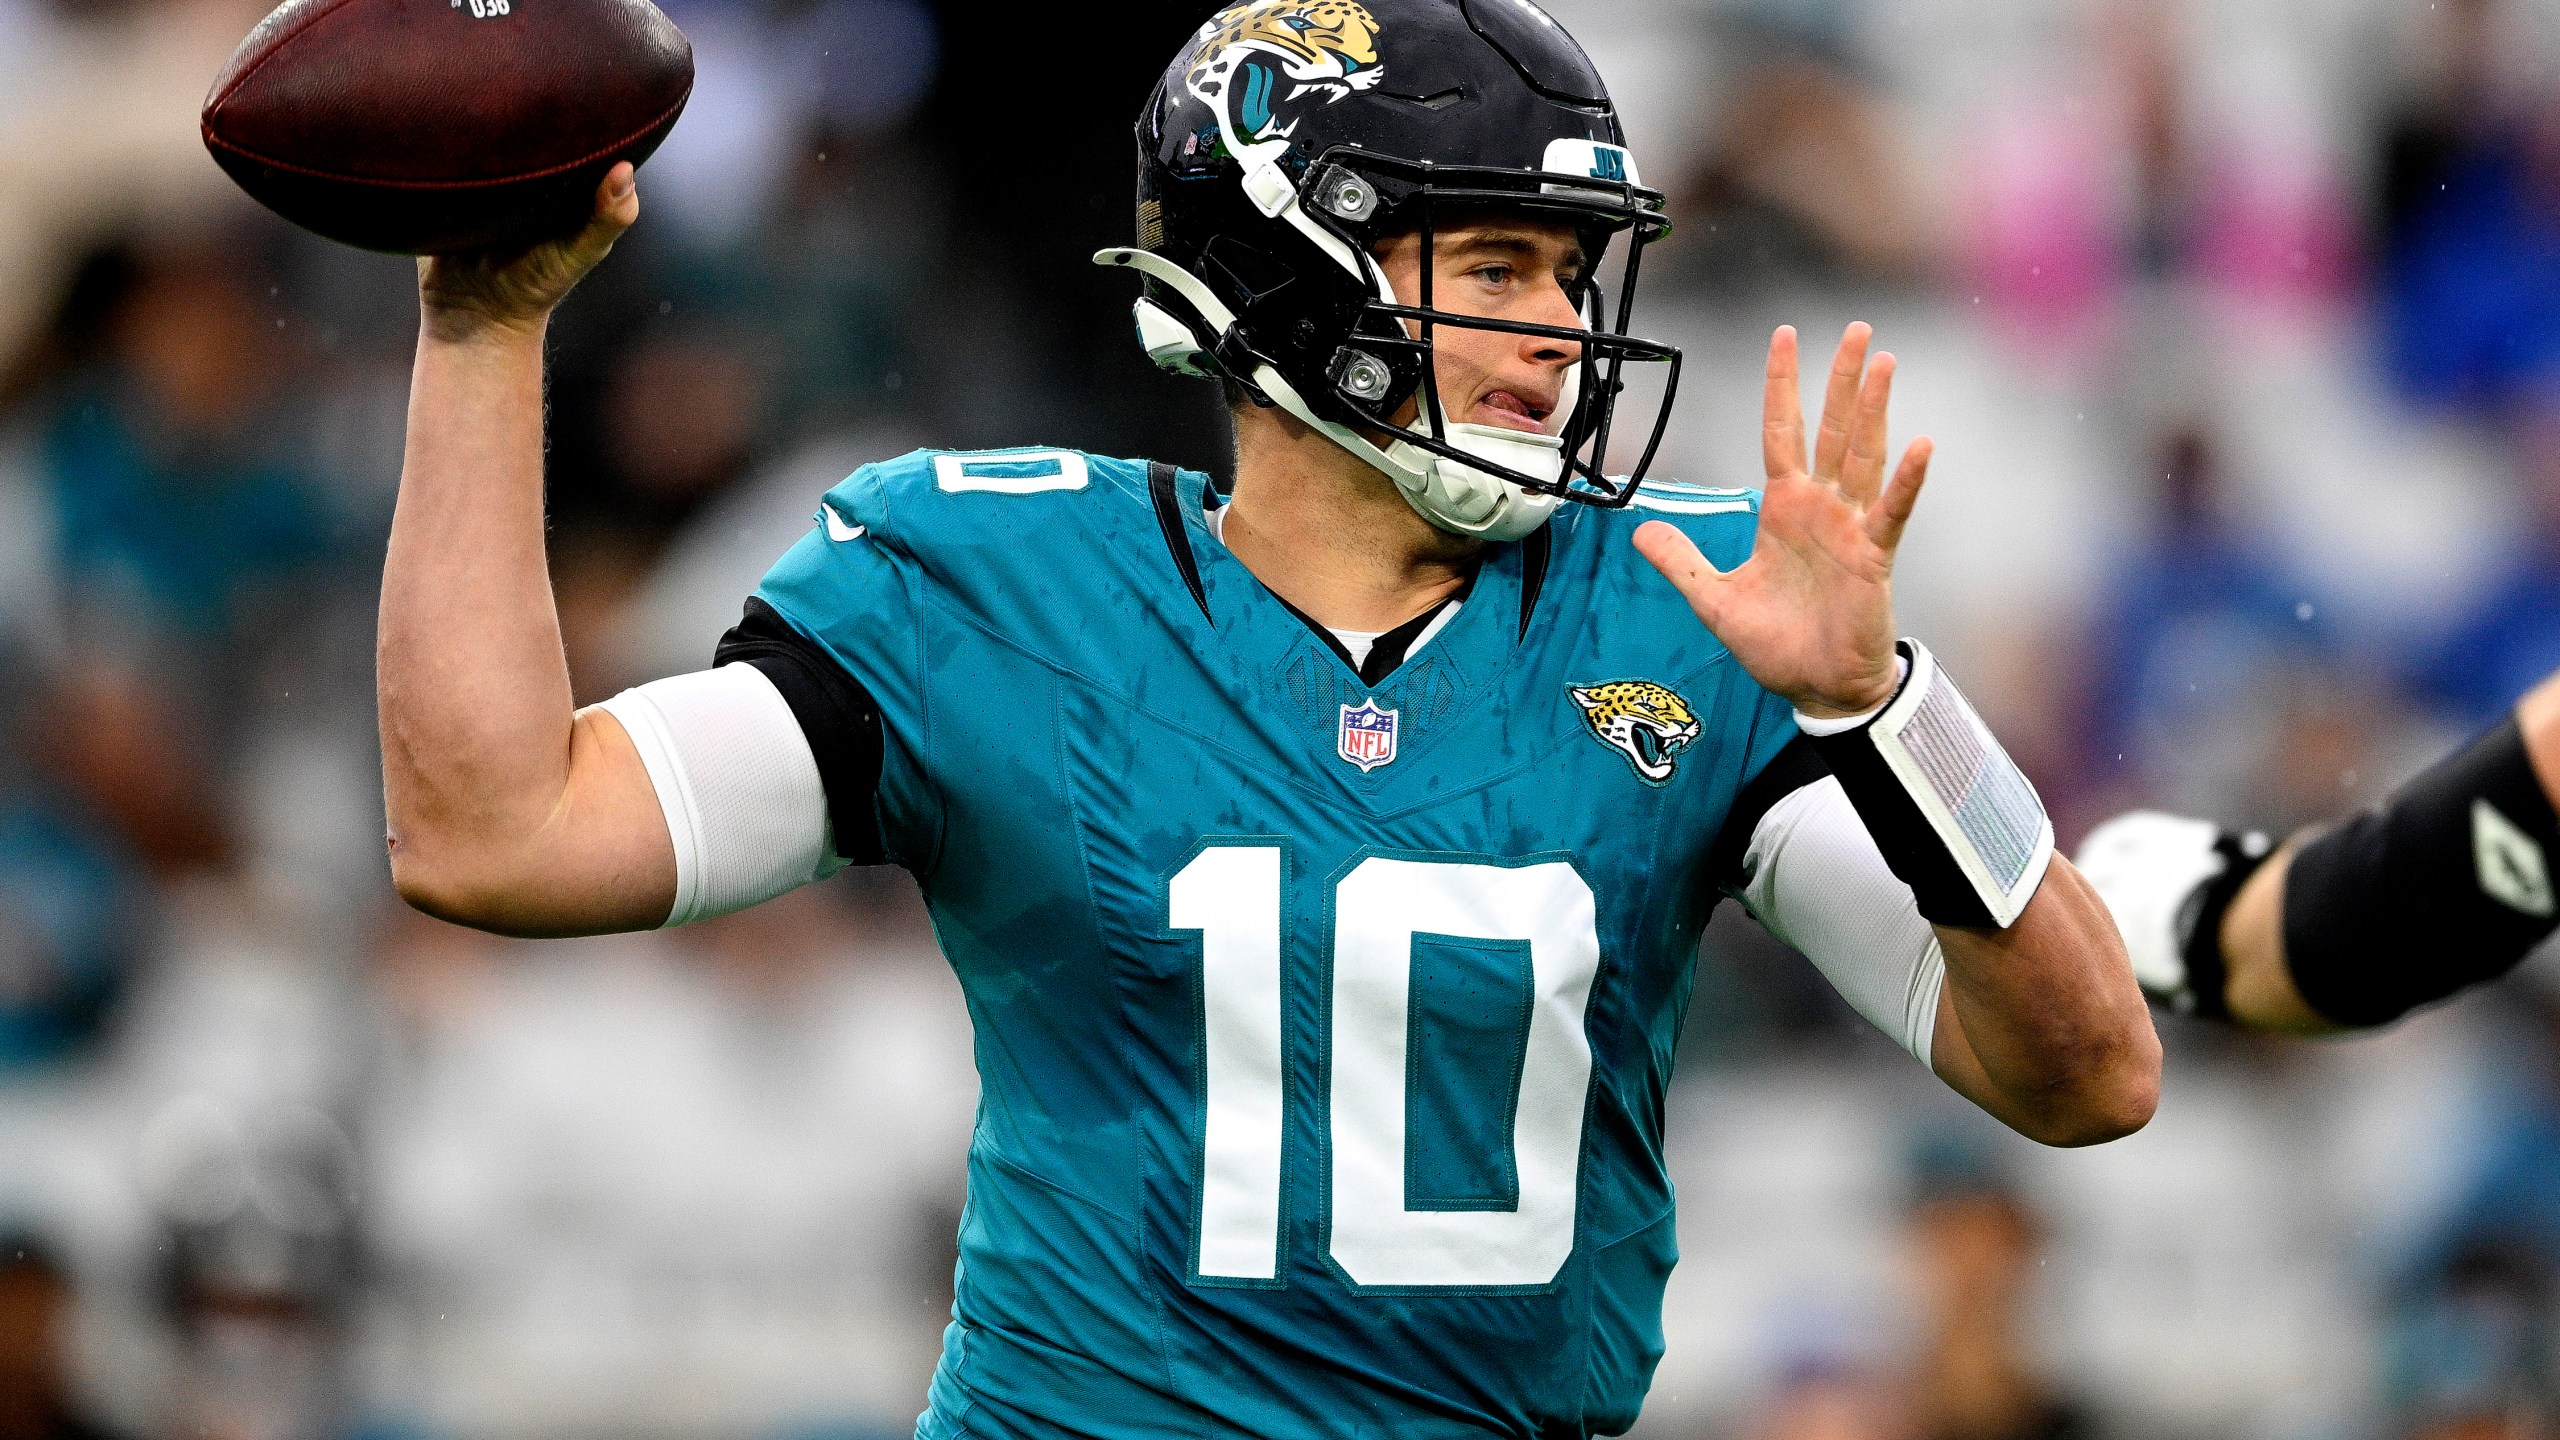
[1805,641,2053,928]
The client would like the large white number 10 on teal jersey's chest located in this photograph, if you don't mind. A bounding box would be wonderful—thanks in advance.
[1167,843,1600,1286]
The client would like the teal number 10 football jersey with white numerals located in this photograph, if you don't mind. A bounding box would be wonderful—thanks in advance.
[758,451,1797,1440]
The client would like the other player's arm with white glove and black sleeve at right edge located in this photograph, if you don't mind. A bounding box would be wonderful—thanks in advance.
[2081,674,2560,1035]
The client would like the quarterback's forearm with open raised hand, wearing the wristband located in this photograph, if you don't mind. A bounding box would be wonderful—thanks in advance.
[1636,325,2161,1145]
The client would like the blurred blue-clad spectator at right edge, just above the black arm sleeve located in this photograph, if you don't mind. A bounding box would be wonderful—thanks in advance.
[2417,405,2560,728]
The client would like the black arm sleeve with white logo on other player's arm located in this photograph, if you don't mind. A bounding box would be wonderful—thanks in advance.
[2284,717,2560,1027]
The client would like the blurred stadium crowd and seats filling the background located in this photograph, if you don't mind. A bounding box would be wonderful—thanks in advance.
[0,0,2560,1440]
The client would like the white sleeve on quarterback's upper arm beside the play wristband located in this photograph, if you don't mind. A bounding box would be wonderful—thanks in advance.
[1741,776,1946,1066]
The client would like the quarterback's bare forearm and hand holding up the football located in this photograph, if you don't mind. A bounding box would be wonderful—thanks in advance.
[376,167,676,935]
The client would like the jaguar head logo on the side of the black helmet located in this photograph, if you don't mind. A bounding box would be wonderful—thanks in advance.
[1183,0,1388,146]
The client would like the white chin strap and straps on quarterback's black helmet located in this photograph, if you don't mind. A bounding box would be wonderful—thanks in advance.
[1093,249,1582,541]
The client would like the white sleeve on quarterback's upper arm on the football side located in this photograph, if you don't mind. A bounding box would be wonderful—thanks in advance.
[602,664,845,925]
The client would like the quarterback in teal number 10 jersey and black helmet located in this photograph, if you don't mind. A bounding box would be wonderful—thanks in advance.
[379,0,2158,1440]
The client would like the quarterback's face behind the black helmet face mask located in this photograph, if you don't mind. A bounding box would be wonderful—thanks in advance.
[1377,215,1585,436]
